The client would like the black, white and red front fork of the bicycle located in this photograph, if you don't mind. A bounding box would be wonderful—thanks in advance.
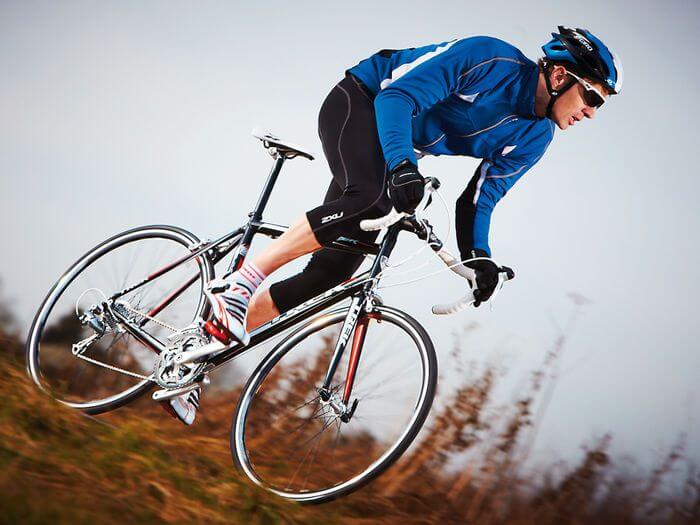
[319,293,369,423]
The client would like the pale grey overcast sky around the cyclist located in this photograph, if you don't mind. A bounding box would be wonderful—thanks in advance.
[0,1,700,472]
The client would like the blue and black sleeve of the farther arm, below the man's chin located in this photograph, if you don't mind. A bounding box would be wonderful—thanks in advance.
[455,157,534,260]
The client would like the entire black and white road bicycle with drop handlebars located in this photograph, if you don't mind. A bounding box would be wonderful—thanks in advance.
[26,129,509,503]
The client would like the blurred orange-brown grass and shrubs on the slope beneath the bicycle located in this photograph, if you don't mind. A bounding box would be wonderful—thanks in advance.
[0,288,700,525]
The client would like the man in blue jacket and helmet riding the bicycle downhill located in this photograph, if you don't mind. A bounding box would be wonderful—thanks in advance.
[165,26,622,424]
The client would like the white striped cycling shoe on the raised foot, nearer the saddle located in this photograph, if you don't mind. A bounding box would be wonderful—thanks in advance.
[204,279,252,345]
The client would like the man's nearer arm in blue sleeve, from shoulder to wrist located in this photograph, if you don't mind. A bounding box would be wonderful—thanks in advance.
[374,37,519,170]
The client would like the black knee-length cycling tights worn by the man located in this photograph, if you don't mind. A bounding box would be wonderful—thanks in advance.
[270,75,391,313]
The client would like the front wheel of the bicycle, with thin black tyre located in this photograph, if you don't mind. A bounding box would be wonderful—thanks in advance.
[231,306,437,503]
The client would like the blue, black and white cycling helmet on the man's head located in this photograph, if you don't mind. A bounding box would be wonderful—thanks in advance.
[542,26,623,95]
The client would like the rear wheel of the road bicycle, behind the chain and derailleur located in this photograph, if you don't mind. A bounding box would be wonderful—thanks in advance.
[27,228,213,412]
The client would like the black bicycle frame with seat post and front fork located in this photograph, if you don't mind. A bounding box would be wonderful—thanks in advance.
[109,151,411,408]
